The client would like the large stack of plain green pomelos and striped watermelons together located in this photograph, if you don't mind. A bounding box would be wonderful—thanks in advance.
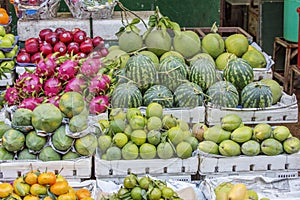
[106,17,282,108]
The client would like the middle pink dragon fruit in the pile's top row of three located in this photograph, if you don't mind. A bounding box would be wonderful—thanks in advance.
[58,60,78,81]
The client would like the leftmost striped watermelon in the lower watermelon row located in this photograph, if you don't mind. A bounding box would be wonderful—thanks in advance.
[111,83,143,108]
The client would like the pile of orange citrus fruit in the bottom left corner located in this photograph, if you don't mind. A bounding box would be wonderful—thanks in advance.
[0,170,93,200]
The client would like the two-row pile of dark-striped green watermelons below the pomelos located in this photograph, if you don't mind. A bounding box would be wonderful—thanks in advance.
[111,52,282,108]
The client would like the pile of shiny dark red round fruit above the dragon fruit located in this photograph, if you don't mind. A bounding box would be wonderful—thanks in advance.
[16,27,108,64]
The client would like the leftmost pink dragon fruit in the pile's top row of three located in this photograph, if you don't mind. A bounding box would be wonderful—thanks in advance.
[36,57,57,77]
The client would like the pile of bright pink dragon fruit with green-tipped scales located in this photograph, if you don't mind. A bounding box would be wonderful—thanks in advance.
[4,52,112,114]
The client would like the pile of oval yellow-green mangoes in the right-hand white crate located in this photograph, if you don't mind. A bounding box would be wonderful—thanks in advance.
[198,114,300,156]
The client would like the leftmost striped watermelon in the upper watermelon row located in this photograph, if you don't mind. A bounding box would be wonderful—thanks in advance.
[125,54,156,91]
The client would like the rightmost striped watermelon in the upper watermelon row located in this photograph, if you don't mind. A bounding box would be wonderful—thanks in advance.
[223,58,254,92]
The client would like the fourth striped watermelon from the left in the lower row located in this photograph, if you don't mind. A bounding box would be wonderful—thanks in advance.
[206,81,239,108]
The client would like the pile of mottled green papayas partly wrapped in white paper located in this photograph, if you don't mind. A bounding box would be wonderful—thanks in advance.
[0,92,97,161]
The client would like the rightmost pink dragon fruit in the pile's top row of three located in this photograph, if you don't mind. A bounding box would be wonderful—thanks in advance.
[80,58,102,77]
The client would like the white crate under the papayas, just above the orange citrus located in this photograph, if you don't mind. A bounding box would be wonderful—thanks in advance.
[0,157,92,180]
